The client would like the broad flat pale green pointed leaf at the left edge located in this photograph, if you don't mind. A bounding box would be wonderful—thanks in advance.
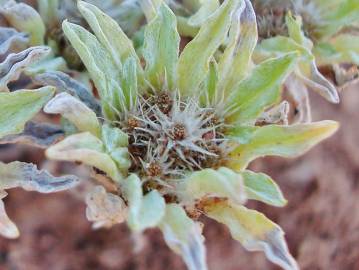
[0,87,55,138]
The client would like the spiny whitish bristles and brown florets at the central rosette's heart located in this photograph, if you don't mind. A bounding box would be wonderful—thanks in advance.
[116,91,232,183]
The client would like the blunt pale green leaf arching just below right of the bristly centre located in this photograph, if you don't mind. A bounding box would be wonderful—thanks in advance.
[177,167,246,204]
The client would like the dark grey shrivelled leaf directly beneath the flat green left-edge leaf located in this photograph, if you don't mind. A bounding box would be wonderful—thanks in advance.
[0,121,64,148]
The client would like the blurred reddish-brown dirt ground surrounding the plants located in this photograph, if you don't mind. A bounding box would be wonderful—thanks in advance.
[0,86,359,270]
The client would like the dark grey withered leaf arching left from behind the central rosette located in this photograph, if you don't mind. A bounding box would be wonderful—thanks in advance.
[34,71,101,116]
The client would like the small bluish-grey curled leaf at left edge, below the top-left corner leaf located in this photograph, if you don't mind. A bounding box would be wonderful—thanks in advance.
[0,27,29,55]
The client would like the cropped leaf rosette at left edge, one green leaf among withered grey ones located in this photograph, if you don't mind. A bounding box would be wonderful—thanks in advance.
[0,44,79,238]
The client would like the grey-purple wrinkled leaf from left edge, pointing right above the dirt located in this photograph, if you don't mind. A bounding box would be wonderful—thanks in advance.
[0,161,79,193]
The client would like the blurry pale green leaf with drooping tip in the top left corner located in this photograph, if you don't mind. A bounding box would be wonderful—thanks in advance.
[0,1,46,45]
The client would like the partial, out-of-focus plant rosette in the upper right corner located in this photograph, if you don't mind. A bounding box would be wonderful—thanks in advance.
[254,0,359,121]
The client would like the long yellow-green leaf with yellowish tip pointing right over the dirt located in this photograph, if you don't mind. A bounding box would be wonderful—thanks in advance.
[229,121,338,170]
